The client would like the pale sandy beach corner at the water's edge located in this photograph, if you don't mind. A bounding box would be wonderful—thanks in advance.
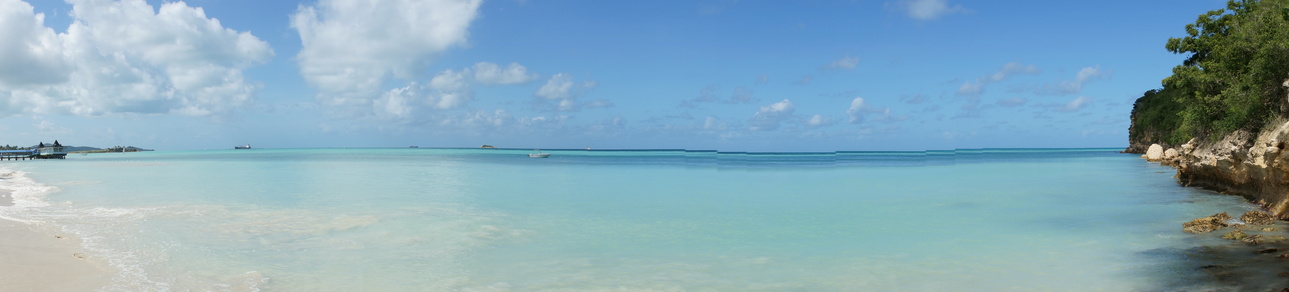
[0,190,111,291]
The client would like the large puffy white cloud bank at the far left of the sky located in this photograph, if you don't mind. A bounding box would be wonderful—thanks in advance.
[0,0,273,116]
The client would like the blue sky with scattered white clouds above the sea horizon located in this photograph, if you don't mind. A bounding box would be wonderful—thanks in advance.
[0,0,1225,152]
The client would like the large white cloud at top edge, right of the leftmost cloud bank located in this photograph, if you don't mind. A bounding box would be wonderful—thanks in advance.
[291,0,481,104]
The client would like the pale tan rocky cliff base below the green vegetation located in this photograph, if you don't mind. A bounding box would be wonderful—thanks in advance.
[1142,121,1289,219]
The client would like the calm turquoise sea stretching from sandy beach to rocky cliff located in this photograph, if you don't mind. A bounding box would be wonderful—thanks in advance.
[0,148,1254,291]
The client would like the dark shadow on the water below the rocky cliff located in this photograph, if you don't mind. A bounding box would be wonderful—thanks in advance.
[1138,231,1289,292]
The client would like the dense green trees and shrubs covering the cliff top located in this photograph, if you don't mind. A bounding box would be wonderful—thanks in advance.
[1129,0,1289,144]
